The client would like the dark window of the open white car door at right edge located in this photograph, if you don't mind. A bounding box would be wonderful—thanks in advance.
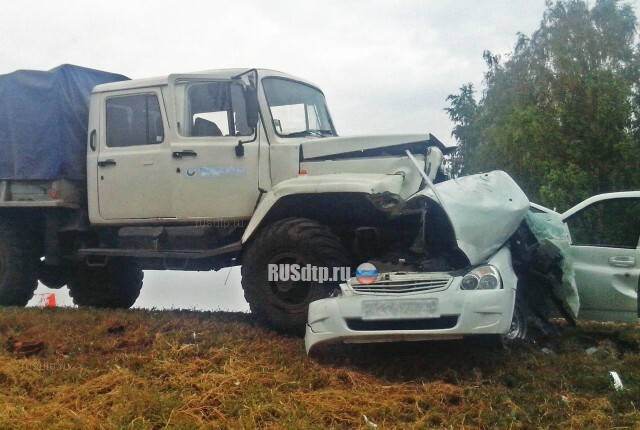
[567,199,640,248]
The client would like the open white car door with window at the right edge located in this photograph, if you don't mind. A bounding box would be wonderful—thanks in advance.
[565,197,640,322]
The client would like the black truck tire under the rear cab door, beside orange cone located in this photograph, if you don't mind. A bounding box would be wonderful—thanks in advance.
[68,259,144,309]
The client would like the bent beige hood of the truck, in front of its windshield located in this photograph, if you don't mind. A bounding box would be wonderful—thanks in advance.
[299,134,456,160]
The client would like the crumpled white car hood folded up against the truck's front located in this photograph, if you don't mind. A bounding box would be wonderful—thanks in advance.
[414,171,529,265]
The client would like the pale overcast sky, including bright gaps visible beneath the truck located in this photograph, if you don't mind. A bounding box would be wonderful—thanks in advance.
[7,0,637,309]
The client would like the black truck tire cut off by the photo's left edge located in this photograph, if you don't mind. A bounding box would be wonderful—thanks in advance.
[0,219,39,306]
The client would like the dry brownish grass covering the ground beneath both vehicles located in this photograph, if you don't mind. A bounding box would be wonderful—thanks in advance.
[0,308,640,429]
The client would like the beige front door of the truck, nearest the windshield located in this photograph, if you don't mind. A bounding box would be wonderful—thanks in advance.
[171,77,259,226]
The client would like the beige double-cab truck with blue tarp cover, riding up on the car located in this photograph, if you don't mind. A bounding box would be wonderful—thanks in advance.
[0,65,568,334]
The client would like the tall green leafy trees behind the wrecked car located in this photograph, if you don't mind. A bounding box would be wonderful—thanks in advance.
[446,0,640,209]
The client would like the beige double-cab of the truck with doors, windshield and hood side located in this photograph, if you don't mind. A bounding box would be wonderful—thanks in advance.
[87,69,436,226]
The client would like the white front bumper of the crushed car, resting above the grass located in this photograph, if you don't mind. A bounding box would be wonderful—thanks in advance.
[305,248,517,353]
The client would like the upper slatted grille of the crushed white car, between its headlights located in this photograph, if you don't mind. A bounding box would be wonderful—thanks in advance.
[348,273,453,294]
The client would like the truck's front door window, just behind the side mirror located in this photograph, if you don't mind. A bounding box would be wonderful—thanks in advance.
[181,82,253,137]
